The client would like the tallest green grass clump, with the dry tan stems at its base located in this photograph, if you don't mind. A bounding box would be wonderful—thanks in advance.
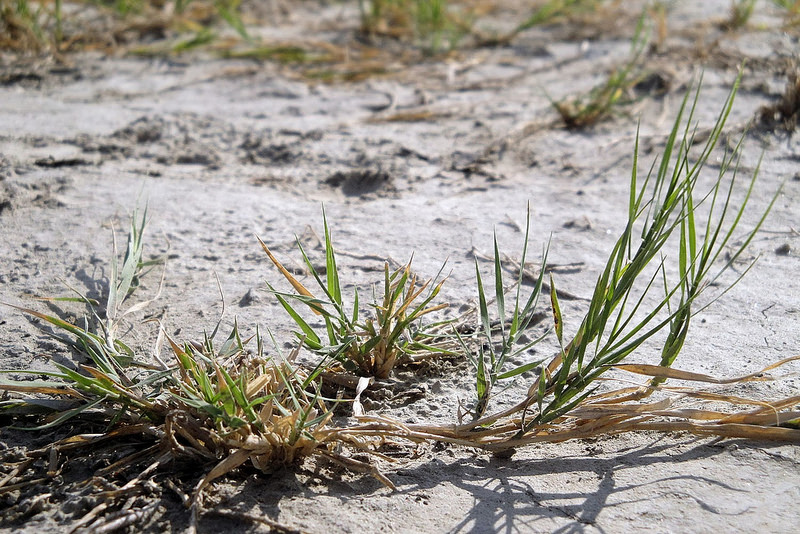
[396,72,800,451]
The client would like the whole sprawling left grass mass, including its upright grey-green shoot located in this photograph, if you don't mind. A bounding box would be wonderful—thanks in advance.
[0,213,391,528]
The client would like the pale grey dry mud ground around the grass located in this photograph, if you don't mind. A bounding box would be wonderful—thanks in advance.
[0,1,800,533]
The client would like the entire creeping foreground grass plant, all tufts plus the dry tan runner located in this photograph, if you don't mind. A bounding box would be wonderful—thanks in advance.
[0,76,800,529]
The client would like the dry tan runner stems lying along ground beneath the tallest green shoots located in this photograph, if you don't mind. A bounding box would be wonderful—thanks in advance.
[350,355,800,452]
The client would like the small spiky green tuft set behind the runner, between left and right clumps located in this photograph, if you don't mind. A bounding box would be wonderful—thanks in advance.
[259,214,447,378]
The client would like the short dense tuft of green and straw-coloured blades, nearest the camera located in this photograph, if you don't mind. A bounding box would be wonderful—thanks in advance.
[164,327,392,499]
